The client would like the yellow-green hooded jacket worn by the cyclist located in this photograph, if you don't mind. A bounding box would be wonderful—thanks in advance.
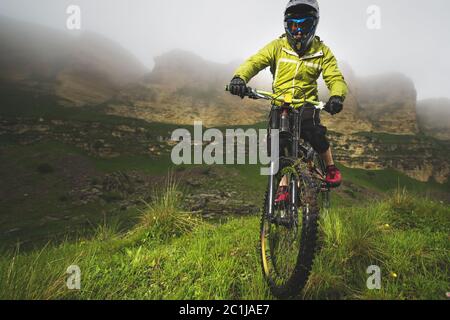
[235,36,348,106]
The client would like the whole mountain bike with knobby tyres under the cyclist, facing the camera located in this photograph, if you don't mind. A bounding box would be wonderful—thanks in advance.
[227,87,331,299]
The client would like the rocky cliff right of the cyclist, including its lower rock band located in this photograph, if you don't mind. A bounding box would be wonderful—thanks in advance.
[321,64,450,183]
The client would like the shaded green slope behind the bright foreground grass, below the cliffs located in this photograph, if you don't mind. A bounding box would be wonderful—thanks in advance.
[0,135,450,247]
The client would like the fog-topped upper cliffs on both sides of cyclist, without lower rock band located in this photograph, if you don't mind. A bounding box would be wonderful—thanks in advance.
[0,17,446,137]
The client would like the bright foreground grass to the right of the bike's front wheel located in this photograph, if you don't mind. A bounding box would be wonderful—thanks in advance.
[304,191,450,299]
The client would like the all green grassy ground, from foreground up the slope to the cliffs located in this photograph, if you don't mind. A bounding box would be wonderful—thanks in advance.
[0,92,450,299]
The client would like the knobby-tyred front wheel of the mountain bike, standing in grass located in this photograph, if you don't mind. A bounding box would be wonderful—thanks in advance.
[260,158,319,299]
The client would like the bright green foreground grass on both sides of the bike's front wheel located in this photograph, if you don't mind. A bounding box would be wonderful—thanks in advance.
[0,182,450,299]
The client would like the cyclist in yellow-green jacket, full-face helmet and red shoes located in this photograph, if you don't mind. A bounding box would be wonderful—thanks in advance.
[229,0,348,196]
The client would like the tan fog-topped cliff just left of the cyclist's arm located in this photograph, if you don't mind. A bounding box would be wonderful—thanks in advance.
[105,50,269,126]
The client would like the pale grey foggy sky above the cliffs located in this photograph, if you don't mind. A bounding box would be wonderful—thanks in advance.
[0,0,450,99]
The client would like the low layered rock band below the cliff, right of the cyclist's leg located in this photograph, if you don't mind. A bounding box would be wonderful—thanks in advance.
[330,133,450,183]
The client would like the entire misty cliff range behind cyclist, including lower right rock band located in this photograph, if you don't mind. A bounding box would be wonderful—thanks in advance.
[0,18,450,182]
